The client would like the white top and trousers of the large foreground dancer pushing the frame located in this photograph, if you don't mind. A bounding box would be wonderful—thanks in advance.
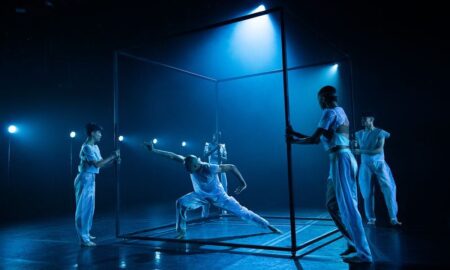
[318,107,372,261]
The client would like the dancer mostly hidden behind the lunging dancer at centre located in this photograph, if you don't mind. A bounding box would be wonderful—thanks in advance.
[202,131,228,217]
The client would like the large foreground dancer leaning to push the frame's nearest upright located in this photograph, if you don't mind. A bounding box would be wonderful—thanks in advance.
[287,86,372,263]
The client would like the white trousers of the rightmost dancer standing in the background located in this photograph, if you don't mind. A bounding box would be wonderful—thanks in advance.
[358,161,398,220]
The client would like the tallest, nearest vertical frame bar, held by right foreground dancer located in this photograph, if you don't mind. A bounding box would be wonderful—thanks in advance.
[280,10,297,257]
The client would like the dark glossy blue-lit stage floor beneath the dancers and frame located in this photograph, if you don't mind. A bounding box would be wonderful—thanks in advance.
[0,211,450,270]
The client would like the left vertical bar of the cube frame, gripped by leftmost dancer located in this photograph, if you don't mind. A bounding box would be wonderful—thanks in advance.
[113,51,120,237]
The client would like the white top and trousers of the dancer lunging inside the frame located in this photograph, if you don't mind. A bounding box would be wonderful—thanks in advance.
[176,163,270,234]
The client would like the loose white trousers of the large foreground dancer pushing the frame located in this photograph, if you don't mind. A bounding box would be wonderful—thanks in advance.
[328,149,372,260]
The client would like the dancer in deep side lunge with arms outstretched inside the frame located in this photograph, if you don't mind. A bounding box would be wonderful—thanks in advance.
[144,142,281,239]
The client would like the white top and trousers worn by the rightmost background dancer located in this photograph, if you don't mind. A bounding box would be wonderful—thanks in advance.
[356,128,398,222]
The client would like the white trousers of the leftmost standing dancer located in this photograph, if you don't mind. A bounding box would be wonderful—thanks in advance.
[74,173,95,243]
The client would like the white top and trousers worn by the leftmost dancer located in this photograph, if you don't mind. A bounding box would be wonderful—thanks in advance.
[74,143,102,243]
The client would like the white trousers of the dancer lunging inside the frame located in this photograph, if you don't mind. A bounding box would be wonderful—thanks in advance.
[176,192,269,233]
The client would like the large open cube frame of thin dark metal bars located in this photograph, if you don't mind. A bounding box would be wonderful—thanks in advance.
[113,8,353,258]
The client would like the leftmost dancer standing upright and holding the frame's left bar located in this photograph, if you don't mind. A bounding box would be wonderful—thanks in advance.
[74,123,120,247]
